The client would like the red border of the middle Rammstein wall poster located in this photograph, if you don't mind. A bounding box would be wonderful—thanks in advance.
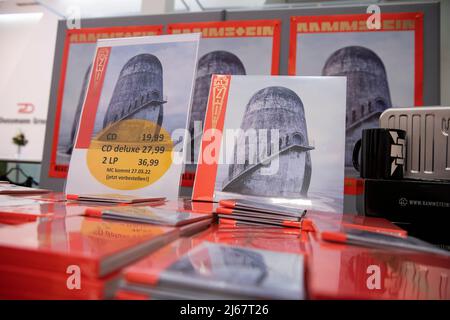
[167,19,281,75]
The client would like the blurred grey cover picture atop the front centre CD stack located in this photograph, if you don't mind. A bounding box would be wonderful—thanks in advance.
[159,242,304,299]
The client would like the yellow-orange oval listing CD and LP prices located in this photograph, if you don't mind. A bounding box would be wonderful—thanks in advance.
[87,119,174,190]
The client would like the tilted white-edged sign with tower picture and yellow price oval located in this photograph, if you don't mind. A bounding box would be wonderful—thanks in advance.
[66,33,200,199]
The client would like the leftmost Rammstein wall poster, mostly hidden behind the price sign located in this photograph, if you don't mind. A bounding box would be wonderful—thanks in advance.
[49,26,162,178]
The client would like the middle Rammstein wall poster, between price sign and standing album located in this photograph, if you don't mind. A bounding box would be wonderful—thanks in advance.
[168,20,281,187]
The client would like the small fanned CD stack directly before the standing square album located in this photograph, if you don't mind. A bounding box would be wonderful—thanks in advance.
[216,199,306,229]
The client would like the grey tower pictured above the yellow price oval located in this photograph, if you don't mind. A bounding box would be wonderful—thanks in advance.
[103,54,166,128]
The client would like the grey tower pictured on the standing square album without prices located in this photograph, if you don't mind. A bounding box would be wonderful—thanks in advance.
[222,87,313,198]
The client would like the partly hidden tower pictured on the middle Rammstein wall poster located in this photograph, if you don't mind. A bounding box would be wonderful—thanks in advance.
[189,50,246,165]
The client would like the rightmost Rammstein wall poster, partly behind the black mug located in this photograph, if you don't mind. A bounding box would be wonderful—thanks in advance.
[289,13,423,187]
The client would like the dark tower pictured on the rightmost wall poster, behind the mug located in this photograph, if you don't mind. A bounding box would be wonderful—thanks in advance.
[322,46,392,167]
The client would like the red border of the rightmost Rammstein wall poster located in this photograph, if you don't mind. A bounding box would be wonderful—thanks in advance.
[288,12,424,195]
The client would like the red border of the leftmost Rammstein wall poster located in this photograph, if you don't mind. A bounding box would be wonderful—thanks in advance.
[48,25,163,178]
